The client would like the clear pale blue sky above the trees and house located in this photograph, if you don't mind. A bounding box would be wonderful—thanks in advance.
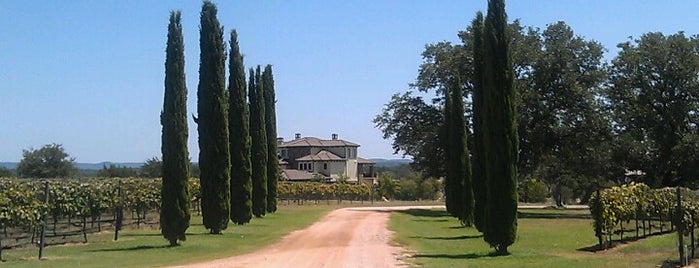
[0,0,699,162]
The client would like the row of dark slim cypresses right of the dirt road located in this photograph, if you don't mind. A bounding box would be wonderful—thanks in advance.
[444,0,518,254]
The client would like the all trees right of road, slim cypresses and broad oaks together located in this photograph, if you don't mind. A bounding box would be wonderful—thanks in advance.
[374,0,699,253]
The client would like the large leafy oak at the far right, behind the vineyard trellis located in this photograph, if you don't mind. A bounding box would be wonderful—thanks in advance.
[605,32,699,186]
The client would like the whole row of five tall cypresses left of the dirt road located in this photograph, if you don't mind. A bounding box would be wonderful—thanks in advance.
[160,1,279,243]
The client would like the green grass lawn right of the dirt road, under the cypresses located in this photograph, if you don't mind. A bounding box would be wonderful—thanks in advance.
[389,209,677,267]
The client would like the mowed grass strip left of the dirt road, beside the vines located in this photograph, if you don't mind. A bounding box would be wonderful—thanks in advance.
[0,205,338,268]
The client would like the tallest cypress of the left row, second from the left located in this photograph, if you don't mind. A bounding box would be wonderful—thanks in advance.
[197,1,231,234]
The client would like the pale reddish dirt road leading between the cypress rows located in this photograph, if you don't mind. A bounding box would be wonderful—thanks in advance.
[171,206,438,268]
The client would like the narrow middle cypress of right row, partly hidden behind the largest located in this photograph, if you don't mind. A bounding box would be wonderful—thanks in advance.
[471,11,487,232]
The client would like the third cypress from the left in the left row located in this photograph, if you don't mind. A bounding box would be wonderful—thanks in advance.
[228,30,252,224]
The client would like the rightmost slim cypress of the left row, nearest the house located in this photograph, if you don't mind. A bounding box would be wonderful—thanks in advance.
[262,64,279,213]
